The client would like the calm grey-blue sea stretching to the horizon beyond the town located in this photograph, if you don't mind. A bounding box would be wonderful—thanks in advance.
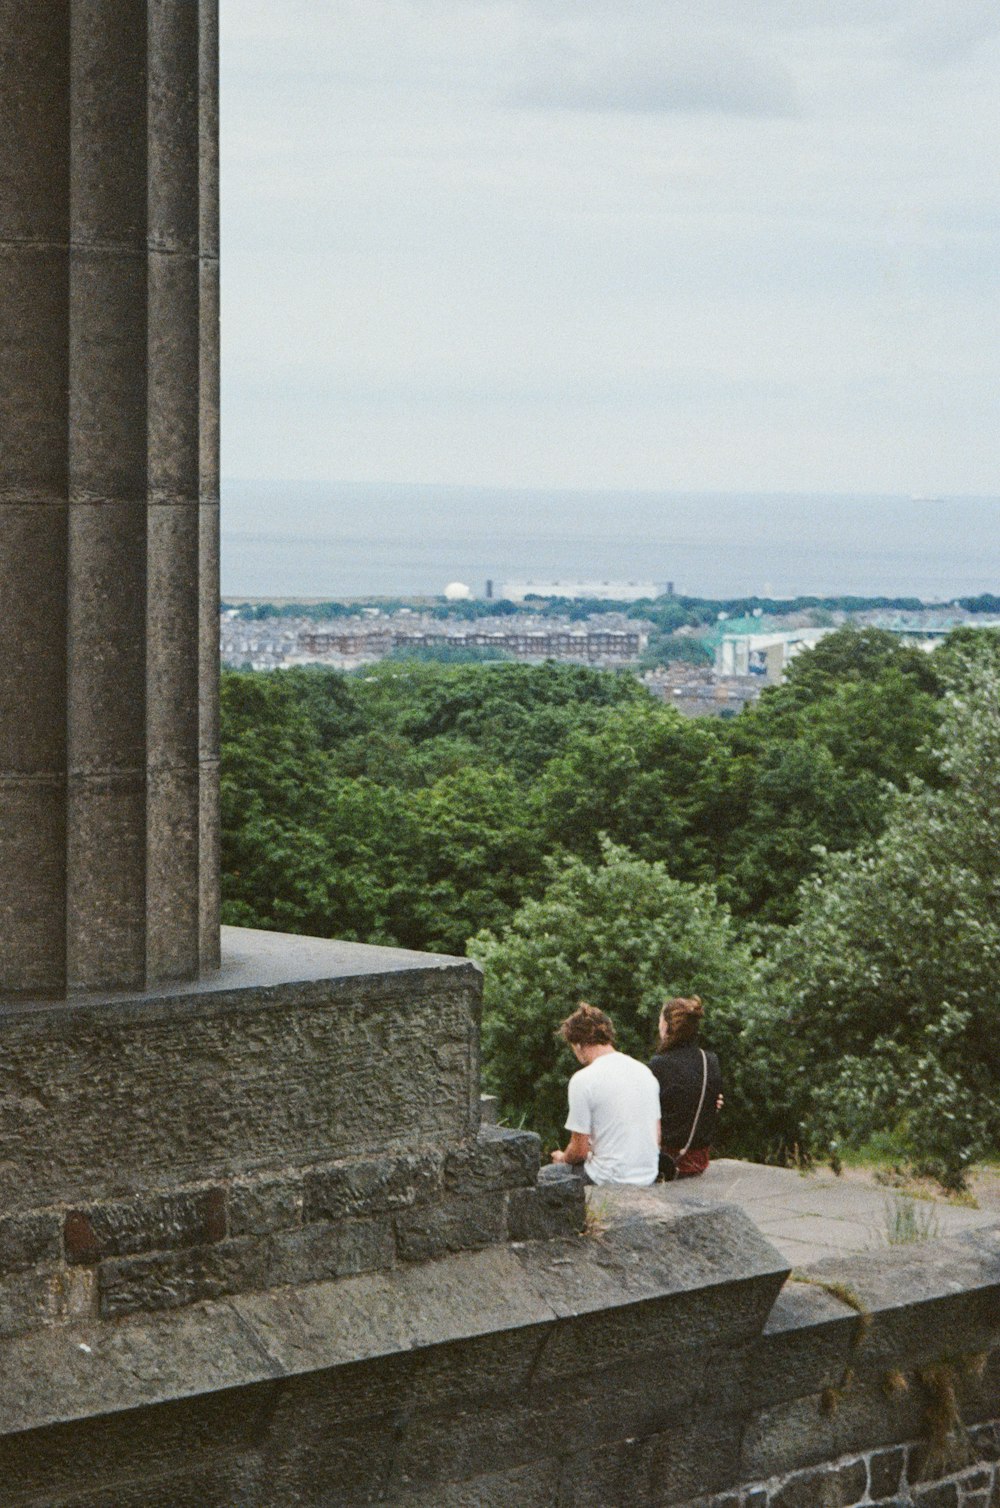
[222,481,1000,600]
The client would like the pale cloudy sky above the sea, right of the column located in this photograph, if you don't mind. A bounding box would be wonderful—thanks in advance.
[222,0,1000,495]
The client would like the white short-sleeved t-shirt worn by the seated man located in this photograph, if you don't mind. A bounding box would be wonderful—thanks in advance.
[566,1053,659,1184]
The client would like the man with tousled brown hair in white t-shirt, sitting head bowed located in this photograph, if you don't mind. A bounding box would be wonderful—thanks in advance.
[552,1004,659,1185]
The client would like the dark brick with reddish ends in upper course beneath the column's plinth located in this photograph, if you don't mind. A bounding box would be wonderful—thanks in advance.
[63,1188,226,1264]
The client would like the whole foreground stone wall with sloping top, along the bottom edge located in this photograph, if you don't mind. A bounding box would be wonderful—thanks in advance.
[0,1191,1000,1508]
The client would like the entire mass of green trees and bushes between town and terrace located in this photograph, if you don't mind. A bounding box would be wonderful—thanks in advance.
[222,629,1000,1182]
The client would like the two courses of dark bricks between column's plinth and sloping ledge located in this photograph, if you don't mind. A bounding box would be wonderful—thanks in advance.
[0,1126,584,1338]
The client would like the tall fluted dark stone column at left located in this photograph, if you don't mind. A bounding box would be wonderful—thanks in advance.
[0,0,219,997]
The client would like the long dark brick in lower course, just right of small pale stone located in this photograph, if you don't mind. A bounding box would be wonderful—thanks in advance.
[98,1237,268,1320]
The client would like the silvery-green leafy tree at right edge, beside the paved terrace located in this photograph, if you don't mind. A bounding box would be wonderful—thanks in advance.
[747,645,1000,1184]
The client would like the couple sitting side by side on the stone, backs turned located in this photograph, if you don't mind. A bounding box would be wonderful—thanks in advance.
[542,995,722,1184]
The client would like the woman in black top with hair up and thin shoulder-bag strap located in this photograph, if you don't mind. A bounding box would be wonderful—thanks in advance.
[650,995,722,1178]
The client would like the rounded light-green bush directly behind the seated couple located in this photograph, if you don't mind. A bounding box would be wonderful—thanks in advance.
[469,843,751,1143]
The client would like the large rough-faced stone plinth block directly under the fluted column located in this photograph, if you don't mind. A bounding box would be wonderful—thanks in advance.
[0,928,481,1214]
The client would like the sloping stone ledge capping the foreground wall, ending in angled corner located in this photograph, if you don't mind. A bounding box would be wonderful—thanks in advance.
[0,1197,787,1439]
